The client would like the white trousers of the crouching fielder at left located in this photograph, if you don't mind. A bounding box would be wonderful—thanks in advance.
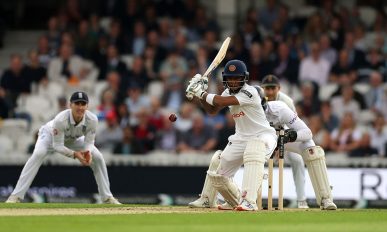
[12,126,112,200]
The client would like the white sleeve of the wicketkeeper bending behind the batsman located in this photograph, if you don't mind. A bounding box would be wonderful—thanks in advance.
[281,108,312,142]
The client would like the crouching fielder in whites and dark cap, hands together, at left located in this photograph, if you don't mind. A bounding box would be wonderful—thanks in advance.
[6,92,121,204]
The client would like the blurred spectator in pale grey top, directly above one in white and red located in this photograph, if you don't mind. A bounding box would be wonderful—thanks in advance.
[331,85,360,119]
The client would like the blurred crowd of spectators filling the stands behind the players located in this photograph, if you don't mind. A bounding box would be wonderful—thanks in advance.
[0,0,387,157]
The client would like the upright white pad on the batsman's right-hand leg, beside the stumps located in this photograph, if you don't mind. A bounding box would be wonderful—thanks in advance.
[242,138,266,202]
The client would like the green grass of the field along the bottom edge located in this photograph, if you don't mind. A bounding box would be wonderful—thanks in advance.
[0,204,387,232]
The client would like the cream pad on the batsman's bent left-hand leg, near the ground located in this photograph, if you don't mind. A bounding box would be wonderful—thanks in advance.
[207,171,240,208]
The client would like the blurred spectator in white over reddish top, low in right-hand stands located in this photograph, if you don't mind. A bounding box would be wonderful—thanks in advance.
[330,112,362,153]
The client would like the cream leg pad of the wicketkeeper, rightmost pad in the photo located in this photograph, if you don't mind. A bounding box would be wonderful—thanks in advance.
[302,146,333,205]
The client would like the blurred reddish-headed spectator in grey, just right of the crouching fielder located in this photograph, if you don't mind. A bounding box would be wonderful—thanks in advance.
[95,111,123,153]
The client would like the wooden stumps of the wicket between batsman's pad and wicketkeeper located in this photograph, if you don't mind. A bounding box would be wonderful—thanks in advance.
[257,127,285,210]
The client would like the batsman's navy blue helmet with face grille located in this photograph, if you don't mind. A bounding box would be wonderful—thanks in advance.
[222,60,249,94]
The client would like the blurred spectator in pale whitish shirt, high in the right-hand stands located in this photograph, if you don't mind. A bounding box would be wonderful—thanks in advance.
[299,42,330,86]
